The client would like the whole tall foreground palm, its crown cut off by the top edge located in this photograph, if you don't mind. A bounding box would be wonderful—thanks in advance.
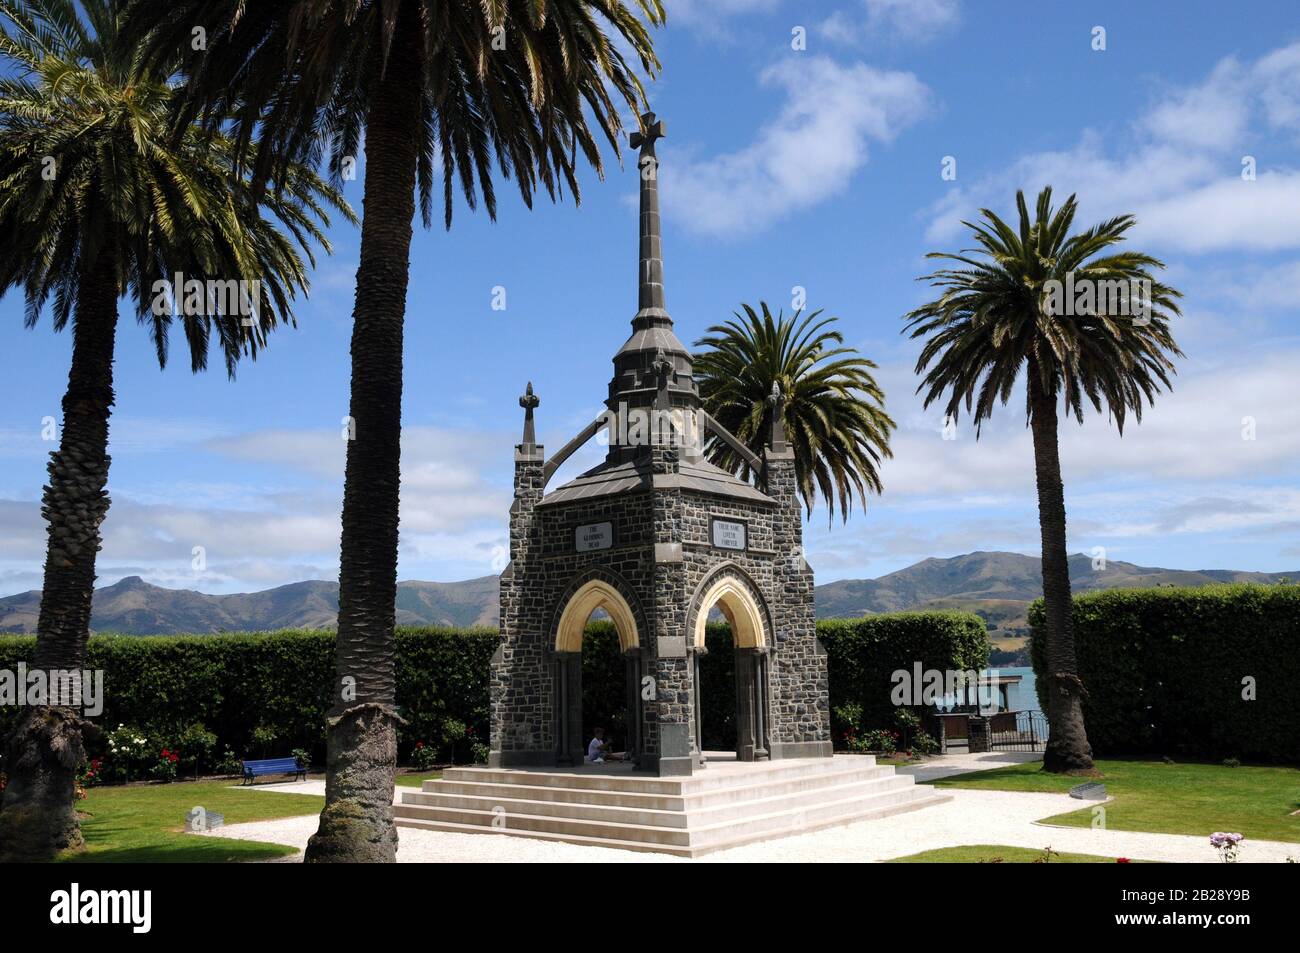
[137,0,663,862]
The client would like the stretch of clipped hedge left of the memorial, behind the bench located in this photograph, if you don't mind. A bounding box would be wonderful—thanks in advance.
[0,628,497,763]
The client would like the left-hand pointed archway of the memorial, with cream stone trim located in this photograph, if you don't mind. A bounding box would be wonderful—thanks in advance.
[554,579,644,766]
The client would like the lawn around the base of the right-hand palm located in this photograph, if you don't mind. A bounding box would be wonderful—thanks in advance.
[935,761,1300,844]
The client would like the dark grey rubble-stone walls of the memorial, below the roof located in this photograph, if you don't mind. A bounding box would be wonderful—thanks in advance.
[491,449,831,774]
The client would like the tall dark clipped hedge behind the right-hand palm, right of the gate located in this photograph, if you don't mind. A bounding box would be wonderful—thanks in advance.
[1030,584,1300,762]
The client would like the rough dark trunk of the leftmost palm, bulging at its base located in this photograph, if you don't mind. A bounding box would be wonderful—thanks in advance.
[0,251,118,861]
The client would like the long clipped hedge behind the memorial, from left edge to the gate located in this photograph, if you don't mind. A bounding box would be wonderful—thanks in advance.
[0,612,988,767]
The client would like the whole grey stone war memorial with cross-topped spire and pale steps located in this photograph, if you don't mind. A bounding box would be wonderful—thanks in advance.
[397,113,945,855]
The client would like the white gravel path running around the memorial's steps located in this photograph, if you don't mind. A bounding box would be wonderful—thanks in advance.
[196,784,1300,863]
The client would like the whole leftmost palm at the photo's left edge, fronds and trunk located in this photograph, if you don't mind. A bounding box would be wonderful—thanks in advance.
[0,0,352,858]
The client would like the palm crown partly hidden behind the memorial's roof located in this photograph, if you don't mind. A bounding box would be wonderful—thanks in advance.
[694,302,894,521]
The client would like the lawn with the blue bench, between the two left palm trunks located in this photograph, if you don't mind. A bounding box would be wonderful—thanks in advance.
[62,780,325,863]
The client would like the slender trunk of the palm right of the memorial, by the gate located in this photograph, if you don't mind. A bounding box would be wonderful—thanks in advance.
[1028,374,1093,772]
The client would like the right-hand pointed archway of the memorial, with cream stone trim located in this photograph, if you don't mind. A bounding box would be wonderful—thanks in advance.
[693,571,770,761]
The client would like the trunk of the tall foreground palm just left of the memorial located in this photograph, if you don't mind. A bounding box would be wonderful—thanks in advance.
[306,3,421,863]
